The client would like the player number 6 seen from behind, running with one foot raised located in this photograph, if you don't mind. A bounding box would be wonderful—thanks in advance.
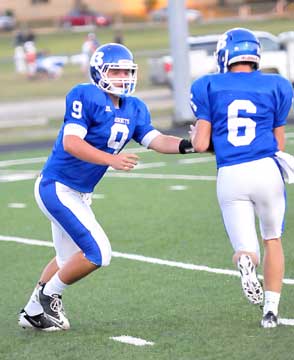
[191,28,293,328]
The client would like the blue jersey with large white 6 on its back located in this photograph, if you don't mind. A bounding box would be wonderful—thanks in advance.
[191,71,293,167]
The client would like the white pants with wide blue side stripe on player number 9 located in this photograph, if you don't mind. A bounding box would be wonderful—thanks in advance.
[35,176,111,267]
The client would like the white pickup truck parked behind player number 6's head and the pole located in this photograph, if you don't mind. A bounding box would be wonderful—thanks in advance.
[148,31,294,87]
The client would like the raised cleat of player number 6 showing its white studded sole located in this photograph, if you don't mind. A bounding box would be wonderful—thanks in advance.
[238,254,263,305]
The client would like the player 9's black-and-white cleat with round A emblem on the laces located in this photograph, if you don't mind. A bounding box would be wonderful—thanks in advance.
[39,286,70,330]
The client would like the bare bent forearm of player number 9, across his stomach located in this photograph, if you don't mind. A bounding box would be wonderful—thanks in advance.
[63,135,113,165]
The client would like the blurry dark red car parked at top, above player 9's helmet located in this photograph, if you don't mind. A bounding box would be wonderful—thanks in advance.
[60,10,112,28]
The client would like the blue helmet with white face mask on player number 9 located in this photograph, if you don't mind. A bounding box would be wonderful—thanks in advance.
[90,43,138,96]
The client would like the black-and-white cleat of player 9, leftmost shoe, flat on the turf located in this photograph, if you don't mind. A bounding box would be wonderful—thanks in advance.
[18,309,62,332]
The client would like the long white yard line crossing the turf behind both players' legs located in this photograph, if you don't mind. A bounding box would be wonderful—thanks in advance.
[0,235,294,285]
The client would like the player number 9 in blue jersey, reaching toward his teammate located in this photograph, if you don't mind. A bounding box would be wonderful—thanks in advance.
[19,43,193,331]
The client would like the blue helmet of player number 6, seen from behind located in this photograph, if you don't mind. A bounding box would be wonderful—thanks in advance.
[215,28,260,73]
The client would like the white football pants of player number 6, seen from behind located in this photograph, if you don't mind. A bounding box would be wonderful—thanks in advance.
[217,158,286,254]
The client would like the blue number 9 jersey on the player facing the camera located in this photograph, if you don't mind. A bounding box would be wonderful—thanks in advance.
[42,84,154,192]
